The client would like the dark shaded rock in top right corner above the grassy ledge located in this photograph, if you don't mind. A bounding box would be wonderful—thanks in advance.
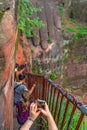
[63,0,87,24]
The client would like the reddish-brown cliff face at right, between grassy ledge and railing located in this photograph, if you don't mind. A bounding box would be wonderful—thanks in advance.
[64,37,87,100]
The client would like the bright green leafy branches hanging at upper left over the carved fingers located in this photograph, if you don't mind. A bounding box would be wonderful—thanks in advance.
[18,0,44,37]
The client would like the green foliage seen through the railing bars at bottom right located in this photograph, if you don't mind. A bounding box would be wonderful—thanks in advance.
[56,98,87,130]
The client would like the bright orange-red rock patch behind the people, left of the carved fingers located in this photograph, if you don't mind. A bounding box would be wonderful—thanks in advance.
[16,35,32,72]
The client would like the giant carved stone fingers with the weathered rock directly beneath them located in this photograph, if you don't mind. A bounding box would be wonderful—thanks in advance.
[31,0,63,73]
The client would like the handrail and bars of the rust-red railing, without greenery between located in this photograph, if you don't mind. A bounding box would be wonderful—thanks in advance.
[27,73,87,130]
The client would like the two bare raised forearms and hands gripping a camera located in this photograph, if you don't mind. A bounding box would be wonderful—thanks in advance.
[20,103,58,130]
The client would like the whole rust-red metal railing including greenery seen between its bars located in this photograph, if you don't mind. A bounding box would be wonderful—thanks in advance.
[27,73,87,130]
